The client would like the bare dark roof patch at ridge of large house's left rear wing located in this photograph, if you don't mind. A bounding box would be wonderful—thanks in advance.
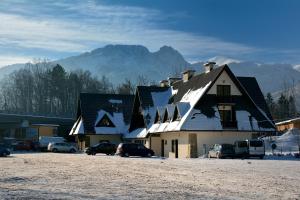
[136,86,169,108]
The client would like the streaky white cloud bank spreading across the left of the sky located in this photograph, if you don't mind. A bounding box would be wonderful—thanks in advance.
[0,0,257,65]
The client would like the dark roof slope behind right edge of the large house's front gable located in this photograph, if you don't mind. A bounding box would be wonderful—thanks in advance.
[237,77,272,119]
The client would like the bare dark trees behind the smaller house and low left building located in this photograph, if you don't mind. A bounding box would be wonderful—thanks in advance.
[0,60,154,117]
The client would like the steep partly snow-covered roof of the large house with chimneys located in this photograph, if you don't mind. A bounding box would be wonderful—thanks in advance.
[124,66,275,138]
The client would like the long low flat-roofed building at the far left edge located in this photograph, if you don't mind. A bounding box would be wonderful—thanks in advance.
[0,113,74,141]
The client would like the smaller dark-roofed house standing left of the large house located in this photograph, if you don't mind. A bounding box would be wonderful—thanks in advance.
[69,93,134,150]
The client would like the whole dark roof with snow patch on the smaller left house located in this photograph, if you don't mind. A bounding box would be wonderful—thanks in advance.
[74,93,134,134]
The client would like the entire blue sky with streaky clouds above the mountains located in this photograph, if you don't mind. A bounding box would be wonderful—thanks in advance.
[0,0,300,66]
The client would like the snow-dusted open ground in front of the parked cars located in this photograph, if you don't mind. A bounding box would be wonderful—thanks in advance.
[0,153,300,199]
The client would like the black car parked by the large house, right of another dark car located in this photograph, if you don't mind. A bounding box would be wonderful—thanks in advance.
[116,143,154,157]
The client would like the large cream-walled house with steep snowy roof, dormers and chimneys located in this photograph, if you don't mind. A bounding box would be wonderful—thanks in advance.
[124,62,275,158]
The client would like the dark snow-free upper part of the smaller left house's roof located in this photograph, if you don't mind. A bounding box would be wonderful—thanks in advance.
[77,93,134,133]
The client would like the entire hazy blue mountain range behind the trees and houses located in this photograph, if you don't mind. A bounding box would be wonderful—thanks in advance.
[0,45,300,97]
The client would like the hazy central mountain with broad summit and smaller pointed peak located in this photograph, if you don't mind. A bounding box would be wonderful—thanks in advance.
[56,45,190,84]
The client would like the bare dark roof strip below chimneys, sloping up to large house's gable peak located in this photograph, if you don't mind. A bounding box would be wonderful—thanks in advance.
[171,65,227,103]
